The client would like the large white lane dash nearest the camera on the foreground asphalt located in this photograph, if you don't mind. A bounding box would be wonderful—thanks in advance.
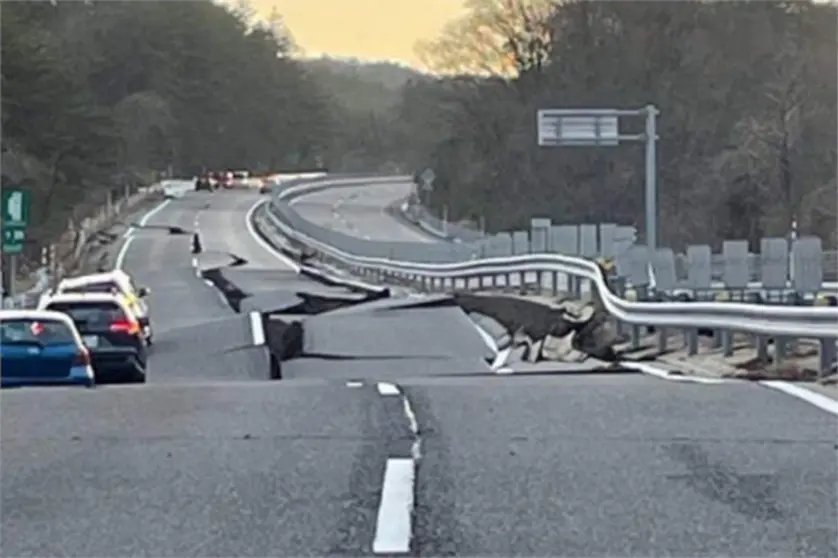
[372,459,416,554]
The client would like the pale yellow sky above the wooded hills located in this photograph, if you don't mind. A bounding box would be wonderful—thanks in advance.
[252,0,472,67]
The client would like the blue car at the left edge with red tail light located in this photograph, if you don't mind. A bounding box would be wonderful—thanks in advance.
[0,310,95,388]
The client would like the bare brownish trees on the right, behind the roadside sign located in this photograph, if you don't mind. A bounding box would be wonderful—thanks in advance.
[360,0,838,248]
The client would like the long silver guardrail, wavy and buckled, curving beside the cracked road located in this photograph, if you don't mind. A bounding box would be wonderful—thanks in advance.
[256,173,838,373]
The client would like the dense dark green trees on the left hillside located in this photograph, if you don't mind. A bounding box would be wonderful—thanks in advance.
[2,1,341,252]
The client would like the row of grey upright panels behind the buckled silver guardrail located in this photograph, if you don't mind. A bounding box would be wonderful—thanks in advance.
[400,197,838,298]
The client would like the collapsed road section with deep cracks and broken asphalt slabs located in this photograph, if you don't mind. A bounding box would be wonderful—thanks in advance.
[199,228,635,379]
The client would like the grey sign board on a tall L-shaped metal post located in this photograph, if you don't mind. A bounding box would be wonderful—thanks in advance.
[538,105,660,251]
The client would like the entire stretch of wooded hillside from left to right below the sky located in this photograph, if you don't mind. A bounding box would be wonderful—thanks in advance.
[2,0,838,258]
